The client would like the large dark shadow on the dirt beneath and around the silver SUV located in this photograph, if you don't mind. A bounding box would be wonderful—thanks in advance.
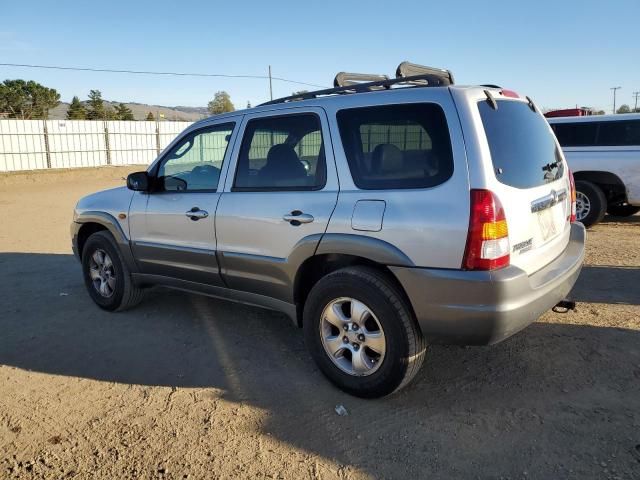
[0,253,640,478]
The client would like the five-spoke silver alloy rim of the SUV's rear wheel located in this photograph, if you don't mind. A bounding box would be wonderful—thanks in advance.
[320,297,387,377]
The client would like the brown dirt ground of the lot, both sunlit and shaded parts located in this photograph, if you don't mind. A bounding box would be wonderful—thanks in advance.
[0,168,640,479]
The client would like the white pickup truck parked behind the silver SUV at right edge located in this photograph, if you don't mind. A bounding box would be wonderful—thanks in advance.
[548,113,640,227]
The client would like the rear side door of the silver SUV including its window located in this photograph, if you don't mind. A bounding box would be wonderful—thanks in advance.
[216,108,338,303]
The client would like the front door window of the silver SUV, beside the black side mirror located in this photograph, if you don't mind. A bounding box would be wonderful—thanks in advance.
[157,123,234,191]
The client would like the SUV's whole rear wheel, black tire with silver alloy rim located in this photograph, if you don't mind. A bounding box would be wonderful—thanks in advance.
[304,267,426,398]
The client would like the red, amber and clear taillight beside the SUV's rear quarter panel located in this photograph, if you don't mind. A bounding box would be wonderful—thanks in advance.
[462,189,510,270]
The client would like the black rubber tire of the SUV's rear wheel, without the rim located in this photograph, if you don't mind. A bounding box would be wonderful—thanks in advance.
[303,267,426,398]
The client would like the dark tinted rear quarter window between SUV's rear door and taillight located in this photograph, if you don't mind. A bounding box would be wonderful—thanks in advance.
[337,103,453,190]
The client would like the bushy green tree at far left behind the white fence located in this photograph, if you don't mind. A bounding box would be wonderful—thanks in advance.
[0,80,60,119]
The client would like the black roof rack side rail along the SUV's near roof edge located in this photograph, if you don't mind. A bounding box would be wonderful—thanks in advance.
[262,73,451,105]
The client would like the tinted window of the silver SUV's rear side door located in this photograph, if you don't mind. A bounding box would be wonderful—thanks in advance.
[234,114,326,191]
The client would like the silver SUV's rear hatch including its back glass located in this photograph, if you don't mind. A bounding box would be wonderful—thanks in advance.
[478,98,571,274]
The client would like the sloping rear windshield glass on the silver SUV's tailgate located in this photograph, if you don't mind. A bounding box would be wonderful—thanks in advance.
[478,100,564,188]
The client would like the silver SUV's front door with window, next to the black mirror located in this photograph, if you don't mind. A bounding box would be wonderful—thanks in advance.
[129,121,235,285]
